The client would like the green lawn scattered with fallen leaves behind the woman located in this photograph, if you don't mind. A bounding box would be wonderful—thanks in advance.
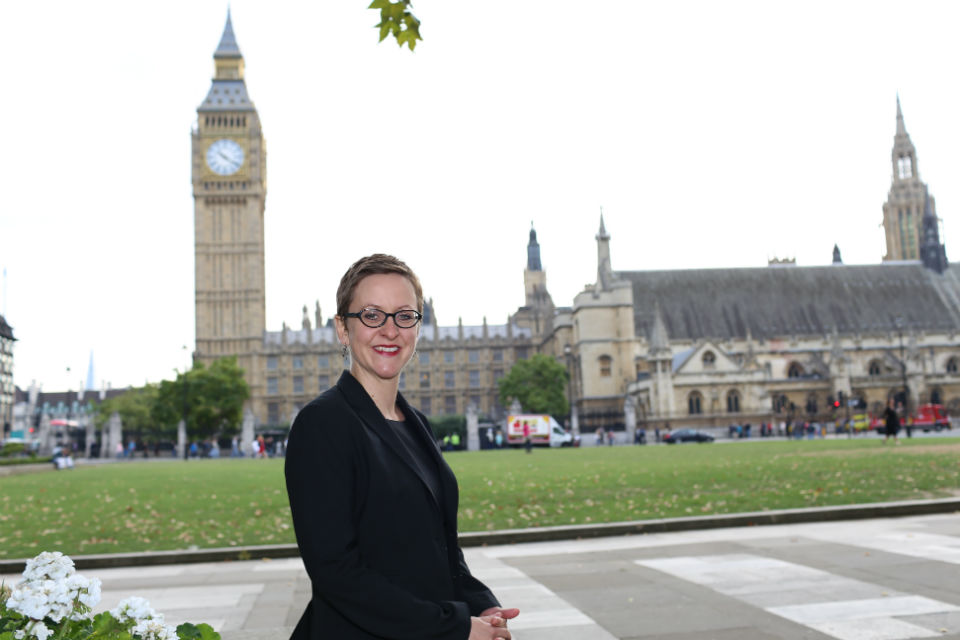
[0,438,960,558]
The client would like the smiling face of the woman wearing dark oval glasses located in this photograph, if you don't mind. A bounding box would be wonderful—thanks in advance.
[336,273,420,384]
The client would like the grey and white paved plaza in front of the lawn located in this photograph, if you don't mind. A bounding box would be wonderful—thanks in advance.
[7,514,960,640]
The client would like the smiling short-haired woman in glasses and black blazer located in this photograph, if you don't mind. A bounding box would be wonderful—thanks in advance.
[285,254,519,640]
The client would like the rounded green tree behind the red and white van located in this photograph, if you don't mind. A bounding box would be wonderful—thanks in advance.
[497,353,570,416]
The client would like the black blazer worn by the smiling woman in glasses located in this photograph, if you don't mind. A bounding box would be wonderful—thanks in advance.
[284,371,499,640]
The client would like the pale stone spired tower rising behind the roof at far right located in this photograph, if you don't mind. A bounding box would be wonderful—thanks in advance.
[883,96,936,260]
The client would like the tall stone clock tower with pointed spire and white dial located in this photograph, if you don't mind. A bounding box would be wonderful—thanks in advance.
[193,11,267,386]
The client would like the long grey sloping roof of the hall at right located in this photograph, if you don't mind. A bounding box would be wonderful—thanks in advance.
[616,262,960,340]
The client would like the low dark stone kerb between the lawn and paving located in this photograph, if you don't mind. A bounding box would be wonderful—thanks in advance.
[0,498,960,574]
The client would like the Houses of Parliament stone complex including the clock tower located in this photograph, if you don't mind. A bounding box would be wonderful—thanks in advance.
[192,15,960,432]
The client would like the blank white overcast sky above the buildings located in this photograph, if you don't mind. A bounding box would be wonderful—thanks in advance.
[0,0,960,391]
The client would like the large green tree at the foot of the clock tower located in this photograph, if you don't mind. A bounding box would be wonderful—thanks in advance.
[153,357,250,439]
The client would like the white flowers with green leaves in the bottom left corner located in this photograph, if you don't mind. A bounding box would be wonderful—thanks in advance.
[0,551,220,640]
